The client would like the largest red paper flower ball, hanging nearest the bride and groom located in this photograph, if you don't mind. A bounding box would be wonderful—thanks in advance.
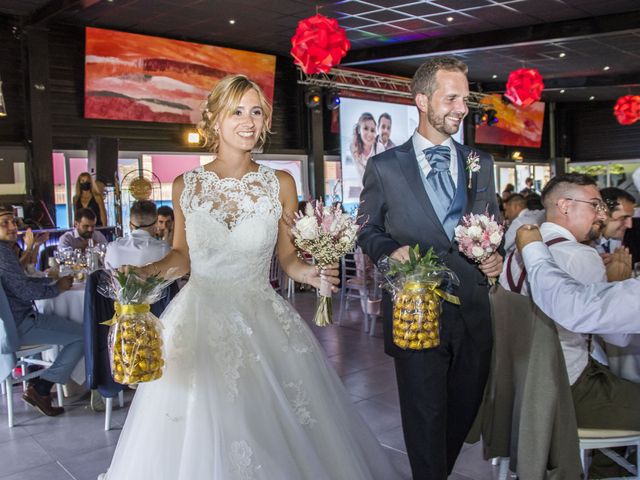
[291,14,351,75]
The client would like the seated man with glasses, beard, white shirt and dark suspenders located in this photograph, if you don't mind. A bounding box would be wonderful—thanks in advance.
[501,173,640,438]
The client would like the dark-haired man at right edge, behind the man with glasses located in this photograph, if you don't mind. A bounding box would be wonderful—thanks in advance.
[594,187,636,265]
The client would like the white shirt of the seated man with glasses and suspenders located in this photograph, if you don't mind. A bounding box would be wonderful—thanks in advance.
[500,222,628,385]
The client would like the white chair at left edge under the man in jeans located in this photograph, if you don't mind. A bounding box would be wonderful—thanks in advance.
[0,282,64,428]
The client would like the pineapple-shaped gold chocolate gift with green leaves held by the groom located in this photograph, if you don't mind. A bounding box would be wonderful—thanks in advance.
[378,245,460,350]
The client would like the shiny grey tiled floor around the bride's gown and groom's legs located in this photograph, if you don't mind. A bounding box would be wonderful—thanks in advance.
[0,293,498,480]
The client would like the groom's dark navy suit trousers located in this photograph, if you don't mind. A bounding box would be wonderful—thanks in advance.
[395,304,491,480]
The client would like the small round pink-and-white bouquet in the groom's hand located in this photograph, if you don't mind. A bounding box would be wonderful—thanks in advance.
[455,211,504,285]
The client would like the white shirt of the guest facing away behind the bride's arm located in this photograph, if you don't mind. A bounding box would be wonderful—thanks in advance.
[104,230,171,270]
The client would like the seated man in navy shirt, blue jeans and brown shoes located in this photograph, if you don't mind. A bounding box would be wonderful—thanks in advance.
[0,207,83,416]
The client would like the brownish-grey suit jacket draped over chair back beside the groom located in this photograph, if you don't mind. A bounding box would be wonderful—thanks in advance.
[480,286,582,480]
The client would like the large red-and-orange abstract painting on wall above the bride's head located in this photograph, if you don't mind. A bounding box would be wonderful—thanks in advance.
[84,28,276,123]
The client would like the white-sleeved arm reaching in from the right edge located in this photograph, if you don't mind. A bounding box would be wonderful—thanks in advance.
[522,242,640,334]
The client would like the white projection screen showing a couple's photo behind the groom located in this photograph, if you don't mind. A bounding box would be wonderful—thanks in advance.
[340,98,462,210]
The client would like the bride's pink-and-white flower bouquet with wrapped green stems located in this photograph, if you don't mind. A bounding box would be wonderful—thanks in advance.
[291,201,358,327]
